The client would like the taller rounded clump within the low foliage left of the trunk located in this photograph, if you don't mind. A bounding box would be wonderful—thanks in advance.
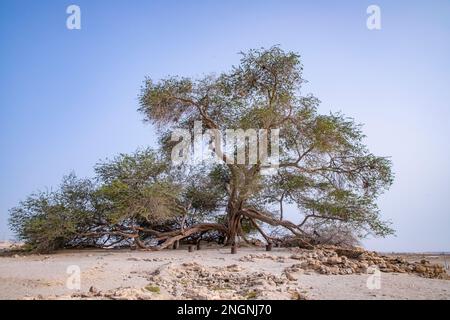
[95,149,179,223]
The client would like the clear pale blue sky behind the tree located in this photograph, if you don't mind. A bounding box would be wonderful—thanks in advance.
[0,0,450,251]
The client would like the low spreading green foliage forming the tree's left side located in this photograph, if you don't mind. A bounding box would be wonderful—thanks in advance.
[9,150,180,252]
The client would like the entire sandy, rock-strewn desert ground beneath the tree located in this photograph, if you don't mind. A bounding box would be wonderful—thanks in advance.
[0,247,450,300]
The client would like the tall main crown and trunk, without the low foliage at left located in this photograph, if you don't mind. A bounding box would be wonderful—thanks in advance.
[139,47,393,248]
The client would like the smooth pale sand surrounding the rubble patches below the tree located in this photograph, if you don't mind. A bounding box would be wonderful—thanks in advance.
[0,248,450,300]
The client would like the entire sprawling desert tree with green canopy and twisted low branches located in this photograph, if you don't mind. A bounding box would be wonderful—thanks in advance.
[10,47,393,251]
